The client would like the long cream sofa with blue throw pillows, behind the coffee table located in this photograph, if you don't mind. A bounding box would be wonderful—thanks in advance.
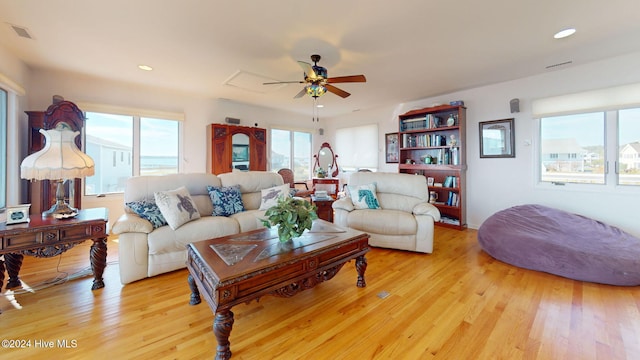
[112,171,284,284]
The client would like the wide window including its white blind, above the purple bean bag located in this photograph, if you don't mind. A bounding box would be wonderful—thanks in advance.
[531,83,640,188]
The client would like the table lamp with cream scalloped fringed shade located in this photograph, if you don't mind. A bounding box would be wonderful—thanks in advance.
[20,122,95,219]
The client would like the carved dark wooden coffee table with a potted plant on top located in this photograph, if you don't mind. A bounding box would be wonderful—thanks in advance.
[187,220,369,359]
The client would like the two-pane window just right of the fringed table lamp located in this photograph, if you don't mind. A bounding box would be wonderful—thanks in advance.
[85,112,180,195]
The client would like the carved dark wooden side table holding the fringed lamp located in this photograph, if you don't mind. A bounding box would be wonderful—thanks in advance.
[0,208,109,300]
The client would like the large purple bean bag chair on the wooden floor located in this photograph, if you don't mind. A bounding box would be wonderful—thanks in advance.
[478,205,640,286]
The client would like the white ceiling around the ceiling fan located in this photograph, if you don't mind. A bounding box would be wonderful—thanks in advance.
[0,0,640,116]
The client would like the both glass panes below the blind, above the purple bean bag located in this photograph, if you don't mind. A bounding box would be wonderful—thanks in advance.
[540,108,640,185]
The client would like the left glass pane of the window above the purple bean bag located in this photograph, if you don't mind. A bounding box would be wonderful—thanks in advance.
[540,112,605,184]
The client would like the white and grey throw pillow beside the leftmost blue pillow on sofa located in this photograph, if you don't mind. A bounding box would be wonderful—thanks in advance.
[153,186,200,230]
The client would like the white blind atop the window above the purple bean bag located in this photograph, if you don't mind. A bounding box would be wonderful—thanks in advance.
[531,84,640,118]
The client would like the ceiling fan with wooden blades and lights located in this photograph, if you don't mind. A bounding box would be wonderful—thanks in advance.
[264,55,367,99]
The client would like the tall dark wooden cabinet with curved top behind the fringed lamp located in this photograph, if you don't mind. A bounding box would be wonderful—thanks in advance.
[25,100,85,214]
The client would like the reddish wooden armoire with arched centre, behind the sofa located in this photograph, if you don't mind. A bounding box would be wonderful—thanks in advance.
[209,124,267,175]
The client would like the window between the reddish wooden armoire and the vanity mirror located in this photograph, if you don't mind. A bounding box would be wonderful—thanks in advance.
[271,129,313,181]
